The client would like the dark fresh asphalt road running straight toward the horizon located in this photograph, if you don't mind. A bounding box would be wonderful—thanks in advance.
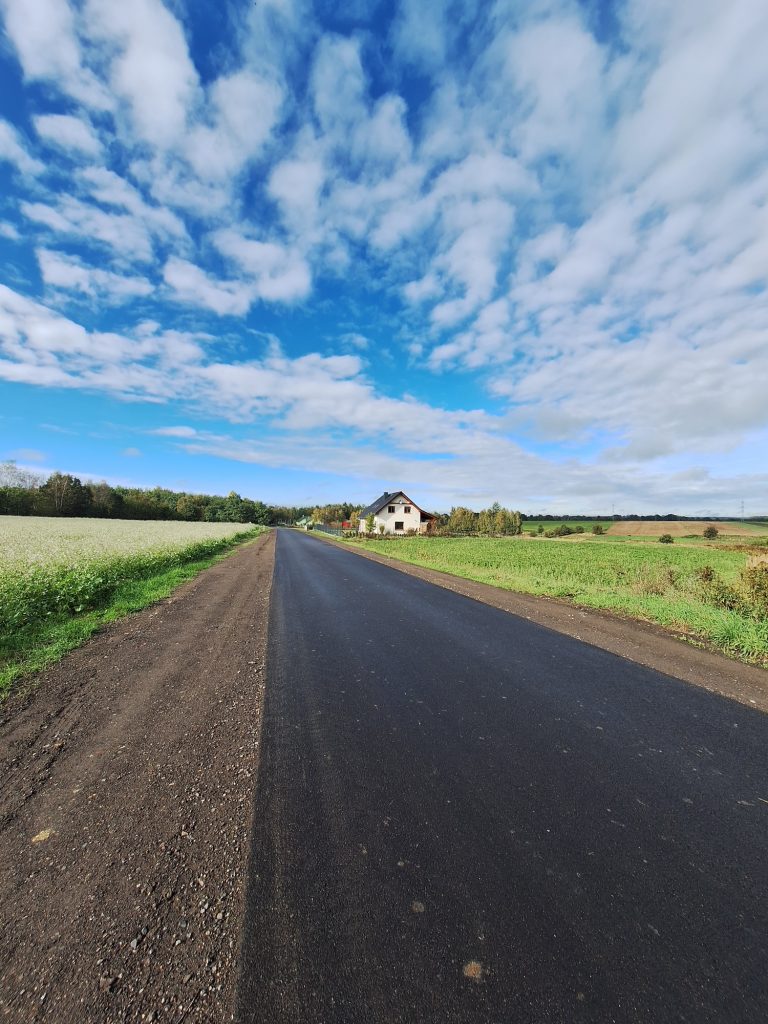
[238,531,768,1024]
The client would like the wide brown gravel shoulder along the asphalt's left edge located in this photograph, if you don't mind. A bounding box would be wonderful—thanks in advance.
[0,531,274,1024]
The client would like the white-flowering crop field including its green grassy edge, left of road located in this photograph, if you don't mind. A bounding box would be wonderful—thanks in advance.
[0,516,262,694]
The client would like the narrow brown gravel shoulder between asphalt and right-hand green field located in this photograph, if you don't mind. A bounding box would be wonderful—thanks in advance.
[310,535,768,712]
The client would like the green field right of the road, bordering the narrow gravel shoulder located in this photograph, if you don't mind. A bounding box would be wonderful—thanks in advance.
[343,538,768,665]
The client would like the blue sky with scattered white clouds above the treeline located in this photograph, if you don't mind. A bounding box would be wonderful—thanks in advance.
[0,0,768,514]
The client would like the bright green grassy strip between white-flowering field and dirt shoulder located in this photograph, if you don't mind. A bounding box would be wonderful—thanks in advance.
[0,529,263,703]
